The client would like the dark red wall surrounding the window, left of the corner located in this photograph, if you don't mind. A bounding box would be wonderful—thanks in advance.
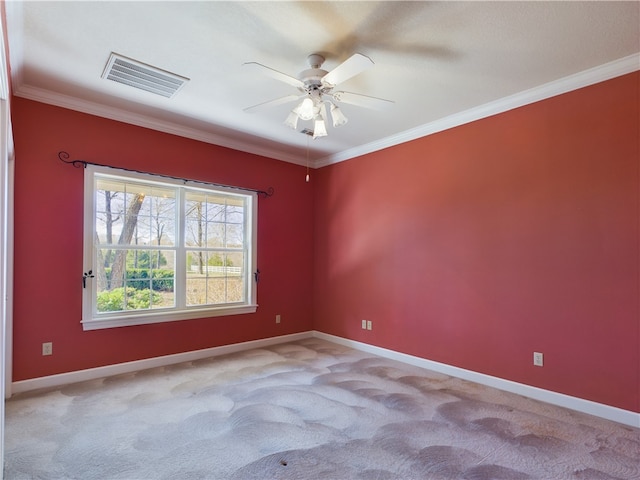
[12,98,313,381]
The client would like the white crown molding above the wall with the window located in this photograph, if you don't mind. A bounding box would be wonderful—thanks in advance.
[13,85,305,166]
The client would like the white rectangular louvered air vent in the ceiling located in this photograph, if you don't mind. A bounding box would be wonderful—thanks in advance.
[102,53,189,98]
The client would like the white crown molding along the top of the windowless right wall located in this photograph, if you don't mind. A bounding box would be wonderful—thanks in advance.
[314,53,640,168]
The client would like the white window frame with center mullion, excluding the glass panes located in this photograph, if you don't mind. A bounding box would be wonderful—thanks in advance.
[82,164,258,330]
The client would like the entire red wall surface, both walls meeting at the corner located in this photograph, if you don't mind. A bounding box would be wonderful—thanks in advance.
[12,72,640,412]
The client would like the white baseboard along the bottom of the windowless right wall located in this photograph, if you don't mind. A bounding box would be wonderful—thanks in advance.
[313,331,640,428]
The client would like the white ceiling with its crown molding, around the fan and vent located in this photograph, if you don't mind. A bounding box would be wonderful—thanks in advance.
[5,0,640,166]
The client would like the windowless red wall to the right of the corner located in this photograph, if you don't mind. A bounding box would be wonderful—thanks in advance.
[314,72,640,412]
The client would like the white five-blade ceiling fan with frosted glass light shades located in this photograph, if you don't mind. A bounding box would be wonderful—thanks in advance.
[243,53,394,138]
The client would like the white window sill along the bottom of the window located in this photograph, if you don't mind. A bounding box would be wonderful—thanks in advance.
[82,305,258,331]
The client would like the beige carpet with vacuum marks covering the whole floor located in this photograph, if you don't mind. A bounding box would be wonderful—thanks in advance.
[5,339,640,480]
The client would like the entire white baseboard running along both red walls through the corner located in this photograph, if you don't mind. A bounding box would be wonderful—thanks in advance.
[11,331,640,428]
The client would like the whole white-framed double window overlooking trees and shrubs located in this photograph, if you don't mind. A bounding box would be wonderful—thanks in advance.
[82,166,257,330]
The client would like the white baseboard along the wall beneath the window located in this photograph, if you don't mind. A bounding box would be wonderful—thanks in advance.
[11,332,313,394]
